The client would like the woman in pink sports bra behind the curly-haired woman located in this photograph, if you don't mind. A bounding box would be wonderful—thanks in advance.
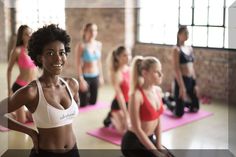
[7,25,37,123]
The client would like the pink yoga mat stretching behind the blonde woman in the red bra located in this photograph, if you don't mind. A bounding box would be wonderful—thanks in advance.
[87,110,213,146]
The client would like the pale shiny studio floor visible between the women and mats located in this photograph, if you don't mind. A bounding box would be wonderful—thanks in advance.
[0,63,228,155]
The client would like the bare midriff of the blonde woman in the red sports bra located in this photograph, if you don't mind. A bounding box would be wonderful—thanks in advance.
[129,119,158,136]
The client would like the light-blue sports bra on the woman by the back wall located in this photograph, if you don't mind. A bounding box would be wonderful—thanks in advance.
[82,43,101,62]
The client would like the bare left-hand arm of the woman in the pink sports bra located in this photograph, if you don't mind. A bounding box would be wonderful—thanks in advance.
[7,48,20,96]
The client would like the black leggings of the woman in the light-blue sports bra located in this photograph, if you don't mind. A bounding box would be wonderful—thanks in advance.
[79,76,99,107]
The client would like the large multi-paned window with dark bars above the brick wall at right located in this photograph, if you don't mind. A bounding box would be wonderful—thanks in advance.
[137,0,236,49]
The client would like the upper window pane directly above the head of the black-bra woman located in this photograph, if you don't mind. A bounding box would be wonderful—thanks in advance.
[180,8,192,25]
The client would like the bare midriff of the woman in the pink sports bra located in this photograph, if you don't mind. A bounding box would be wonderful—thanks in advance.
[17,68,37,83]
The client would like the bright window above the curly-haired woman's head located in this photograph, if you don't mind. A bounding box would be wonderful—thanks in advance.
[16,0,65,30]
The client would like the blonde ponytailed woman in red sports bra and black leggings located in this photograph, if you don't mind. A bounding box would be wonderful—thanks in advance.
[121,56,172,157]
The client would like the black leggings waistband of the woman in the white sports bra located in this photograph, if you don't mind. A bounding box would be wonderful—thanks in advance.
[29,144,80,157]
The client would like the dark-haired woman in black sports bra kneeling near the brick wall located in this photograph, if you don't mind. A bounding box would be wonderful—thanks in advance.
[167,26,199,117]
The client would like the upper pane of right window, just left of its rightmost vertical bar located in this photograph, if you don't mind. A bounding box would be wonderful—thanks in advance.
[209,7,224,26]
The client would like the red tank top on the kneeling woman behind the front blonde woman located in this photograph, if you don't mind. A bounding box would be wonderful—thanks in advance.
[116,70,130,102]
